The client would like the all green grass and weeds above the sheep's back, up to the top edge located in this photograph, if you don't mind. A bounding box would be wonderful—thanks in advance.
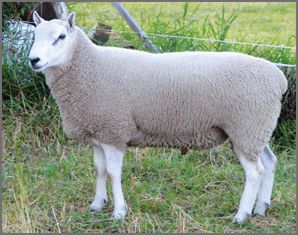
[69,2,296,64]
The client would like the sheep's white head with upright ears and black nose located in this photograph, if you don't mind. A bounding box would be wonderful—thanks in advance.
[29,11,75,71]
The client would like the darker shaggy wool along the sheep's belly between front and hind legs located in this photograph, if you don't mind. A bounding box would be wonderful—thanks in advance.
[128,128,227,149]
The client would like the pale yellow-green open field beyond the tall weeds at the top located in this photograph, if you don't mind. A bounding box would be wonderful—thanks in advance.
[69,2,296,46]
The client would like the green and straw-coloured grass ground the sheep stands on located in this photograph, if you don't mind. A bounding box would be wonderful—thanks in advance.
[2,99,296,232]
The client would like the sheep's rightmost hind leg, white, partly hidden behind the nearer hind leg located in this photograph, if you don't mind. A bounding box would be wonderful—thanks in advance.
[254,146,277,216]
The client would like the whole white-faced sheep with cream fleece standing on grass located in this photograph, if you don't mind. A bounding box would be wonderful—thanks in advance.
[29,12,287,223]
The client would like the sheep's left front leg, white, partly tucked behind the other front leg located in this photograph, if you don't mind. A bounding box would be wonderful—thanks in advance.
[90,145,107,212]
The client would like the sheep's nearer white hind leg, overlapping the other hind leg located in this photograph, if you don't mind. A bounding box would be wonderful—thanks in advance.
[233,146,264,223]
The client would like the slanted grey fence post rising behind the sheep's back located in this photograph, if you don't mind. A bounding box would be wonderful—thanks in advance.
[112,2,159,53]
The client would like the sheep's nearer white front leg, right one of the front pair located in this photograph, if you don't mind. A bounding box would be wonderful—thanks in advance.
[102,144,127,219]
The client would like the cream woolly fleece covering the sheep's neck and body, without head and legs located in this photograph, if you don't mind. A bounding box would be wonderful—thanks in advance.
[44,24,287,160]
